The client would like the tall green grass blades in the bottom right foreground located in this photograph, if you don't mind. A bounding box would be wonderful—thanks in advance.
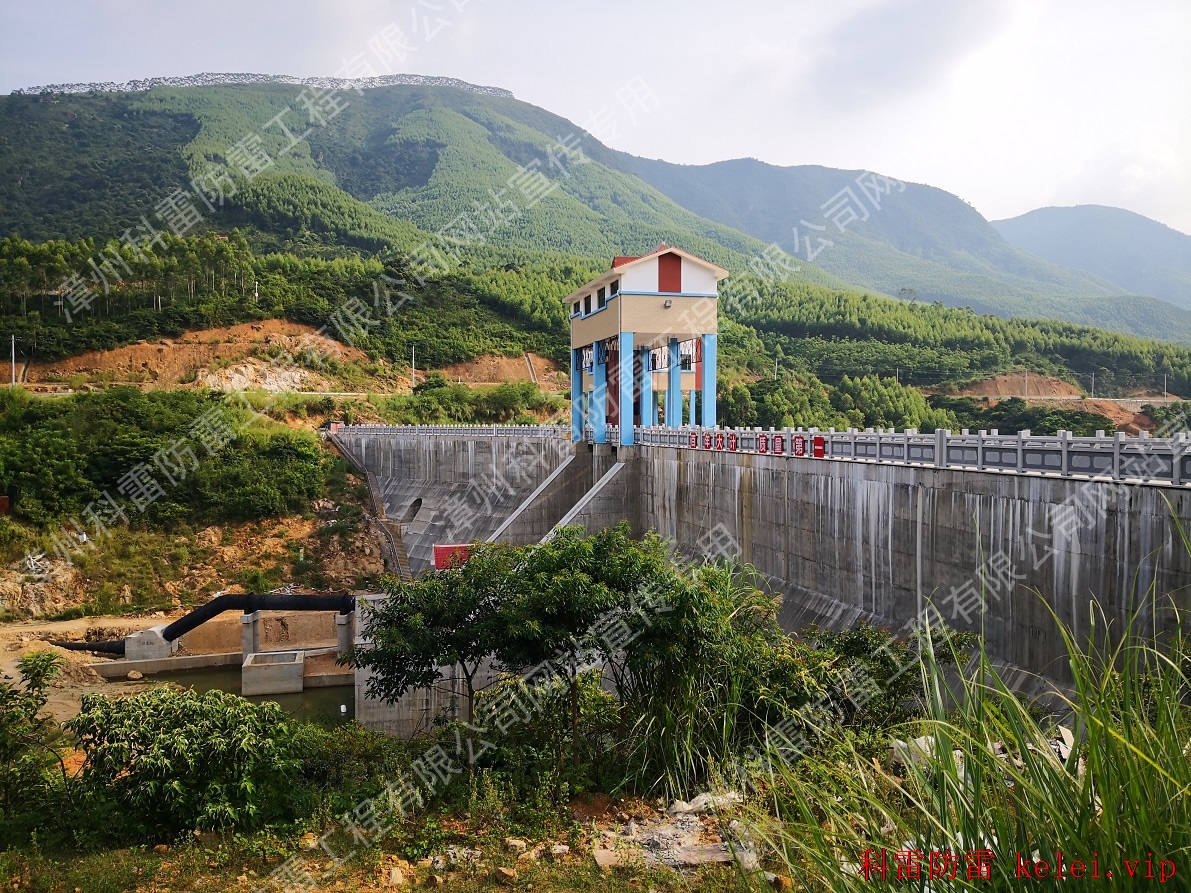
[756,602,1191,891]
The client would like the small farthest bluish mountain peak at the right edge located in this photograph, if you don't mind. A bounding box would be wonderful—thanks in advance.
[992,205,1191,308]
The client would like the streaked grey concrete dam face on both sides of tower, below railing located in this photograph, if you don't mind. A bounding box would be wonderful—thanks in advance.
[344,436,1191,702]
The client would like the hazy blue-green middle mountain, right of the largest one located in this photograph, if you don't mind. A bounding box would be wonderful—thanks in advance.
[622,155,1187,338]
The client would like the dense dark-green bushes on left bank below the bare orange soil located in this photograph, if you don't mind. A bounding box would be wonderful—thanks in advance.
[0,388,324,536]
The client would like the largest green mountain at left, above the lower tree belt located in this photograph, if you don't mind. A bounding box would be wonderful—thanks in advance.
[0,83,849,287]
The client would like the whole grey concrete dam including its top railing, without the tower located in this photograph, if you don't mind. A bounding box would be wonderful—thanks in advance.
[331,426,1191,680]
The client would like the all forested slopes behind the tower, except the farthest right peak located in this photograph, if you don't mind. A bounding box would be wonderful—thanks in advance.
[0,76,1191,411]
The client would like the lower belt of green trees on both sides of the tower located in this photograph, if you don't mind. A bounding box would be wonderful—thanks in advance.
[0,231,1191,395]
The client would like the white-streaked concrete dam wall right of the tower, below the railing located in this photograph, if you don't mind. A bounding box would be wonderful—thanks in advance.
[619,447,1191,679]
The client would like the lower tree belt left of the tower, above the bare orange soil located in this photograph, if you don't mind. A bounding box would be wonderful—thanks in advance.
[0,230,592,368]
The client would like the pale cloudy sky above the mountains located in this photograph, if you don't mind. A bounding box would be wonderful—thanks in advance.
[0,0,1191,233]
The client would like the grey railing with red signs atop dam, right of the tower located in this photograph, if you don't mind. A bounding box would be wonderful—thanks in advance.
[628,426,1191,486]
